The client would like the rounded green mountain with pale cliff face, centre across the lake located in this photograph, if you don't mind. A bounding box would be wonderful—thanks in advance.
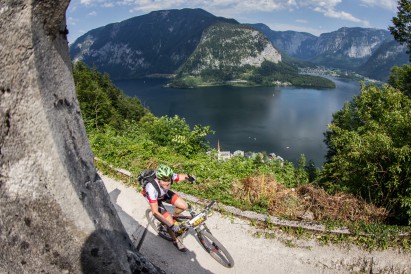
[169,23,335,88]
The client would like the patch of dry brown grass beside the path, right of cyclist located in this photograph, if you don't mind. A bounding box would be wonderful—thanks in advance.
[233,175,388,223]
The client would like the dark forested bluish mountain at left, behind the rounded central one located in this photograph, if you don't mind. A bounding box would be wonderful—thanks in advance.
[70,9,238,79]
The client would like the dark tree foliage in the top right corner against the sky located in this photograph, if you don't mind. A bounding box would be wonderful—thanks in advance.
[388,0,411,61]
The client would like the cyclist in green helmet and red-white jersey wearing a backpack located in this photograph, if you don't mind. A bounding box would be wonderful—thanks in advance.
[143,165,195,252]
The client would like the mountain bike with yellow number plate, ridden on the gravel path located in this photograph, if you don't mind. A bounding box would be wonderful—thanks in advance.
[146,201,234,268]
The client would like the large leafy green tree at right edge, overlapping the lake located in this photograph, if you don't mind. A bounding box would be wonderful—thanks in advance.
[322,86,411,223]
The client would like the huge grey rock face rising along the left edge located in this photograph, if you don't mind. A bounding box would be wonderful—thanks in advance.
[0,0,158,273]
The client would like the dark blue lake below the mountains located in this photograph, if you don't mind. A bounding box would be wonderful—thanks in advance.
[114,78,360,167]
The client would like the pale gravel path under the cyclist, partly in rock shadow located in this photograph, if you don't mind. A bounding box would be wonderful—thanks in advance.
[102,175,411,274]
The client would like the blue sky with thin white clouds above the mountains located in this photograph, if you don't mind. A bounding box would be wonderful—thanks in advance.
[66,0,397,43]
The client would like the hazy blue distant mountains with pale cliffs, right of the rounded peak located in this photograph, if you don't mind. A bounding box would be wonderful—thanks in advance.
[250,24,408,81]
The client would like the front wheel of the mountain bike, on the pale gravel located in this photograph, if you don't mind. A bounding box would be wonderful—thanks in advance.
[198,230,234,268]
